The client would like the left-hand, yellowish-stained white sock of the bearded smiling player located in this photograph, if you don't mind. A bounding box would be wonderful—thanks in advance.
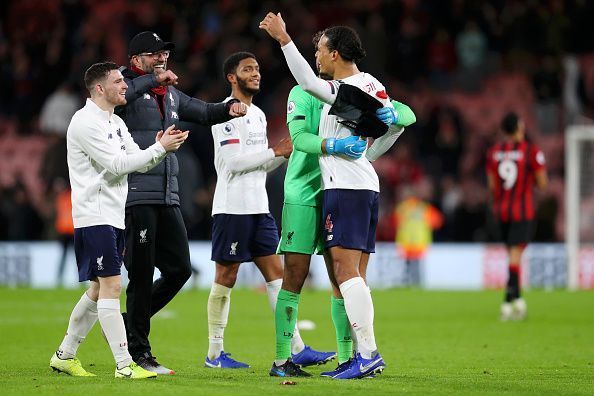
[207,282,232,360]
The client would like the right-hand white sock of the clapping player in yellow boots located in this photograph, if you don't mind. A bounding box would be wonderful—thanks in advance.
[97,298,132,369]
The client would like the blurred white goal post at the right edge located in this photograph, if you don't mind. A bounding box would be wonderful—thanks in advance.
[565,125,594,290]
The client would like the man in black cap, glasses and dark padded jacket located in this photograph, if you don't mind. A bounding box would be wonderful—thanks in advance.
[116,32,247,374]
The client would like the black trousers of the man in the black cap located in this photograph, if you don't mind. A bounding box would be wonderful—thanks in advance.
[124,205,192,360]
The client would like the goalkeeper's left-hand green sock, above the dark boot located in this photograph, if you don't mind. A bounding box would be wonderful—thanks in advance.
[274,289,300,361]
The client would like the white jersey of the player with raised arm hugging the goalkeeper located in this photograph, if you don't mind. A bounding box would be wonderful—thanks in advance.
[320,72,392,192]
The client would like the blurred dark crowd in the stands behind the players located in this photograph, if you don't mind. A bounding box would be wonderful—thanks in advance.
[0,0,594,242]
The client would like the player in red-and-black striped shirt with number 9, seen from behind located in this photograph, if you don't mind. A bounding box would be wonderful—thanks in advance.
[487,113,547,321]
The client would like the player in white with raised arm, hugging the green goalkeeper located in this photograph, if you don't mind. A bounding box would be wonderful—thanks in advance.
[260,13,403,379]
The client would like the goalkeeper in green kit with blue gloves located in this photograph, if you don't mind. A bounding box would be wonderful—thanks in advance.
[270,85,416,377]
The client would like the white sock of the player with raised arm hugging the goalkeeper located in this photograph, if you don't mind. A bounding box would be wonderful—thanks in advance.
[339,277,377,359]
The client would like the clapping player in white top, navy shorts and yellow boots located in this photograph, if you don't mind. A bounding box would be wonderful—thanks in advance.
[50,62,188,379]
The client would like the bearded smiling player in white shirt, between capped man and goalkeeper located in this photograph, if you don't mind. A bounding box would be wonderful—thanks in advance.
[204,52,336,369]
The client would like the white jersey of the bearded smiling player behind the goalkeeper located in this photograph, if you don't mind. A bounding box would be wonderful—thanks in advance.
[211,98,274,215]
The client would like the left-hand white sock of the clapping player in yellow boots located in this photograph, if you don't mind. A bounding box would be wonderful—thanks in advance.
[56,292,97,359]
